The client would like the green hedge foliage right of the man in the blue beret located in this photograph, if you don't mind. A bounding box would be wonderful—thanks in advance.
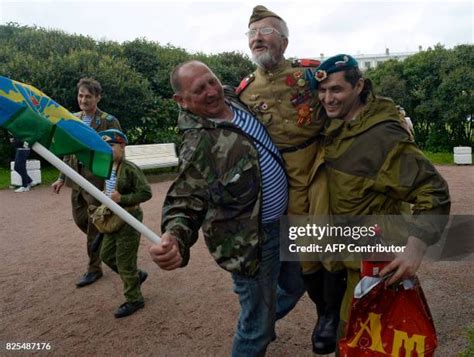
[367,44,474,152]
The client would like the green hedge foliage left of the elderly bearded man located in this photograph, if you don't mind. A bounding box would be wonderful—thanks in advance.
[0,23,254,165]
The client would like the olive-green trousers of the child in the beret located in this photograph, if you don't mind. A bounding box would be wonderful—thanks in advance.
[100,211,143,303]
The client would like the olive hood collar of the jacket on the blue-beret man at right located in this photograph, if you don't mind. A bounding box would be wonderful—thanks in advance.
[324,96,400,138]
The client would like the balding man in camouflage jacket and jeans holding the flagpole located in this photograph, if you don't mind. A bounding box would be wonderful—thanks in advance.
[150,61,304,356]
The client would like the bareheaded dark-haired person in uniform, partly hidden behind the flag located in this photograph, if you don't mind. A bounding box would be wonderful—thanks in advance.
[52,78,121,288]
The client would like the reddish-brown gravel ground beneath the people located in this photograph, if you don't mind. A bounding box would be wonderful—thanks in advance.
[0,166,474,357]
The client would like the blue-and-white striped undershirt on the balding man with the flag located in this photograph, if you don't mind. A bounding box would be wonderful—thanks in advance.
[232,106,288,223]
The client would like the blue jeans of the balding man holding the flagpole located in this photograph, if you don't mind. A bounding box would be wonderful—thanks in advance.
[232,221,305,357]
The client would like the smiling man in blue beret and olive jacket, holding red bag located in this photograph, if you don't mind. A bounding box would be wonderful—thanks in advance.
[310,54,450,344]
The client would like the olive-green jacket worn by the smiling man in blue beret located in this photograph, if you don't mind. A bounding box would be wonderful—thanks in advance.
[310,97,451,244]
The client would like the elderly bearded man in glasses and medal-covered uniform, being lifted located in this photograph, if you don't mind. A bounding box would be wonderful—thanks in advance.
[237,5,345,354]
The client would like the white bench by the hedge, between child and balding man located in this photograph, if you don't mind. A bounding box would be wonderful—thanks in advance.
[125,143,179,170]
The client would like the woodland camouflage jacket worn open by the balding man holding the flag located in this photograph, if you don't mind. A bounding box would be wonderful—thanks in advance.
[162,91,263,276]
